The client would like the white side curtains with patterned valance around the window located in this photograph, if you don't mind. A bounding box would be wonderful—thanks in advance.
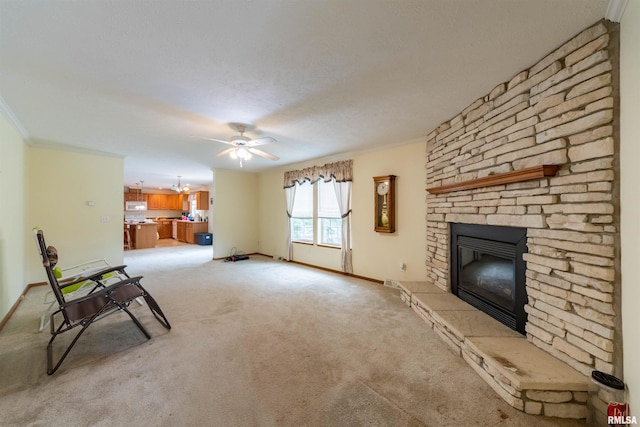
[284,160,353,273]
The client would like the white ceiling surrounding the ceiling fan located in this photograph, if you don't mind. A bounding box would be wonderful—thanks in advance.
[0,0,609,191]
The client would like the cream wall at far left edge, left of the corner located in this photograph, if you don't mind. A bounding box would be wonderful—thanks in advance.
[0,114,26,320]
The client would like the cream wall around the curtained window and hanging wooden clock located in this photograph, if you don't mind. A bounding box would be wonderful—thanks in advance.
[258,142,425,280]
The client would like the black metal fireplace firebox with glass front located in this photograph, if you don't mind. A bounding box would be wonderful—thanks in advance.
[451,223,527,334]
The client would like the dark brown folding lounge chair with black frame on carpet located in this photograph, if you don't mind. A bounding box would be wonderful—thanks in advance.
[36,230,171,375]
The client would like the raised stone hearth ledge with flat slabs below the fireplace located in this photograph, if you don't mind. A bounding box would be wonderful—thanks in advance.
[395,282,592,418]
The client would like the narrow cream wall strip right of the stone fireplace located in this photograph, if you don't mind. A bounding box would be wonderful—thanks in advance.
[620,1,640,417]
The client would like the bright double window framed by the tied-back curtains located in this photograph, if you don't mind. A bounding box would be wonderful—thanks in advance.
[291,180,342,248]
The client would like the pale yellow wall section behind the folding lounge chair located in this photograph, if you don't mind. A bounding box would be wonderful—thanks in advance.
[24,147,124,283]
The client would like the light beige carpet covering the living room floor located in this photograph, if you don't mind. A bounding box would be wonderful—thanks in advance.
[0,242,583,427]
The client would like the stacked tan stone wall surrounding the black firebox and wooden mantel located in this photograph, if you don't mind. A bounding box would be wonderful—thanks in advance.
[426,21,620,390]
